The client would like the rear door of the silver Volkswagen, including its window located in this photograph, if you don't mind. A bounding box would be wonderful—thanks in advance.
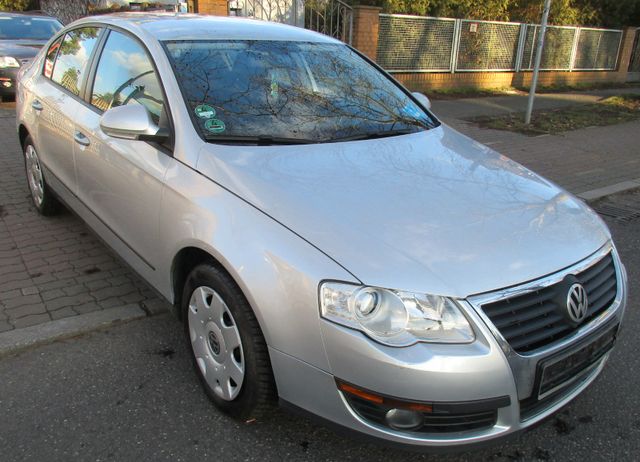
[29,27,103,193]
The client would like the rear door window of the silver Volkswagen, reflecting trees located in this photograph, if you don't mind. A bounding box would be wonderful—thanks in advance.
[51,27,101,95]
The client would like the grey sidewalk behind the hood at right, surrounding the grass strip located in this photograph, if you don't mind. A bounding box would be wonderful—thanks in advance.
[433,88,640,199]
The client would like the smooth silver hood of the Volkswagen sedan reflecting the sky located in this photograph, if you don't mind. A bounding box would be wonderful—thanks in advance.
[197,126,610,297]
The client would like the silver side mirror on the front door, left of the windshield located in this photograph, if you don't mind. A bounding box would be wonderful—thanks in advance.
[100,104,166,141]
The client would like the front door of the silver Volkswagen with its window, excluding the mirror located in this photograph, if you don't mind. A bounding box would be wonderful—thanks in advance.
[74,30,173,280]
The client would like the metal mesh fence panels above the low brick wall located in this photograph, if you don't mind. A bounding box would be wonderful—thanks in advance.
[378,14,624,72]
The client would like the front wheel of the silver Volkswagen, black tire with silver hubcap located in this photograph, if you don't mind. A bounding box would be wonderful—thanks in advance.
[182,263,277,421]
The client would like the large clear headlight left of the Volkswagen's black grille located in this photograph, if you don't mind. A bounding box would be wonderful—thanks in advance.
[320,282,475,346]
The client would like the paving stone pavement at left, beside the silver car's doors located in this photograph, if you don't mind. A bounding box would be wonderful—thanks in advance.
[0,109,168,332]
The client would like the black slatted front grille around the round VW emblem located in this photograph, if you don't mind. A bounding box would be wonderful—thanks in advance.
[482,253,618,353]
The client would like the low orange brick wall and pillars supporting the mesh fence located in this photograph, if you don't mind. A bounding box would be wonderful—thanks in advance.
[352,6,636,92]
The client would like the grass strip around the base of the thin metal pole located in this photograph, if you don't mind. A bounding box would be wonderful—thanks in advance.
[470,94,640,136]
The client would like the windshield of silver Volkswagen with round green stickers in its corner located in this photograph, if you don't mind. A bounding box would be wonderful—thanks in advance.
[165,40,437,142]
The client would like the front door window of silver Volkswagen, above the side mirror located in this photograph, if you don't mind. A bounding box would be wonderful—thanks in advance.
[91,31,164,123]
